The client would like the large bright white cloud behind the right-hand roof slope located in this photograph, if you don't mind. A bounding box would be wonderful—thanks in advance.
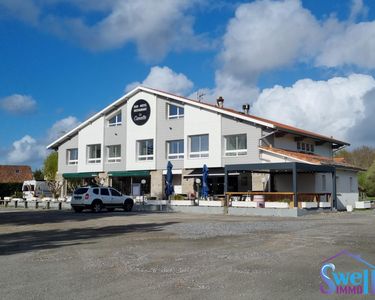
[252,74,375,139]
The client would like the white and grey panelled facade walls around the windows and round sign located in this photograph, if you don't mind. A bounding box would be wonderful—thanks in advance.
[49,87,358,205]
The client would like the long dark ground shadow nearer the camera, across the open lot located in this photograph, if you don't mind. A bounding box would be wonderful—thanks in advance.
[0,222,176,256]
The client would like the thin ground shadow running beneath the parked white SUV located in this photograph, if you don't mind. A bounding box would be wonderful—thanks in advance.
[0,209,160,226]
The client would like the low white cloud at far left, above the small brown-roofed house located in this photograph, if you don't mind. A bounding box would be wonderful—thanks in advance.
[7,135,47,164]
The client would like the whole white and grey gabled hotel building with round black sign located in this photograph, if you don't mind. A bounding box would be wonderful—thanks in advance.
[48,87,358,208]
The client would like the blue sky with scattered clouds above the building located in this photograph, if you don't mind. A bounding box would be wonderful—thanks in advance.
[0,0,375,168]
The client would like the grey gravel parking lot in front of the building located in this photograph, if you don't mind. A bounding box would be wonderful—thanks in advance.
[0,209,375,299]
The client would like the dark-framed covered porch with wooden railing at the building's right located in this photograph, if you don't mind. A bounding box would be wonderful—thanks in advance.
[224,162,337,209]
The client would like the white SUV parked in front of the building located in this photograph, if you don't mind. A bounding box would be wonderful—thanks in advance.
[70,186,134,213]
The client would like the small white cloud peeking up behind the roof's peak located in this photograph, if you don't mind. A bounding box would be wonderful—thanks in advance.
[125,66,194,95]
